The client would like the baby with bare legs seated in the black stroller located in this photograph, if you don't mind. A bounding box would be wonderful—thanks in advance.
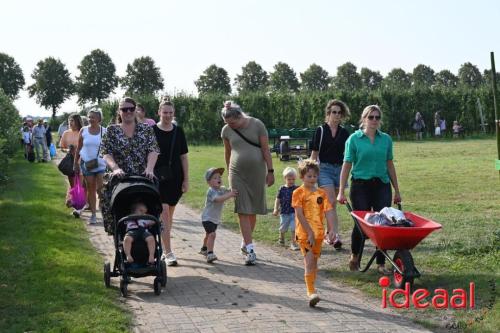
[123,200,156,265]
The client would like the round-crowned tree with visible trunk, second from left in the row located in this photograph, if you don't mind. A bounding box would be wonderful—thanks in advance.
[28,57,75,118]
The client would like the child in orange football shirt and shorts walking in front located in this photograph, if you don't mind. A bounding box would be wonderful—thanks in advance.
[292,159,335,307]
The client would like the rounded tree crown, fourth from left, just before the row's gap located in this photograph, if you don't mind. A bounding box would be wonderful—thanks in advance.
[120,56,163,95]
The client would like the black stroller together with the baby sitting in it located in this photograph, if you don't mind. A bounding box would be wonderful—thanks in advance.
[104,175,167,297]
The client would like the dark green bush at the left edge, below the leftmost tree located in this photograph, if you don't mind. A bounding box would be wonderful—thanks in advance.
[0,88,22,178]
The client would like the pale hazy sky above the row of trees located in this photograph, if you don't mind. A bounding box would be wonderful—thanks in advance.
[0,0,500,116]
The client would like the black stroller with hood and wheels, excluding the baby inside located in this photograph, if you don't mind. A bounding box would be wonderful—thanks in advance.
[104,176,167,297]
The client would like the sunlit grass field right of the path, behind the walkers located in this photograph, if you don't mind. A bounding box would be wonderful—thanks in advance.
[183,138,500,332]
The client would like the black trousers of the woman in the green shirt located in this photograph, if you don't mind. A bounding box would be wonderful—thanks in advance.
[350,178,392,265]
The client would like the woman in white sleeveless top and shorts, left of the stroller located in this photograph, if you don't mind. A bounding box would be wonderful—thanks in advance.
[74,109,106,224]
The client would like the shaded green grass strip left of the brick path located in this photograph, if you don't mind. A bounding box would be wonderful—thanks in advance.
[0,157,131,332]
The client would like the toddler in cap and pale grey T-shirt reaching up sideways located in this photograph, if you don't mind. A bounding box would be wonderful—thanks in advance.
[200,168,238,263]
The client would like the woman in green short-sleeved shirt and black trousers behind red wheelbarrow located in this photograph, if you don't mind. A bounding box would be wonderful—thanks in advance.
[337,105,401,274]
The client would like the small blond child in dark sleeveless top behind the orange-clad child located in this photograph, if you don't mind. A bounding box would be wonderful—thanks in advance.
[273,167,299,251]
